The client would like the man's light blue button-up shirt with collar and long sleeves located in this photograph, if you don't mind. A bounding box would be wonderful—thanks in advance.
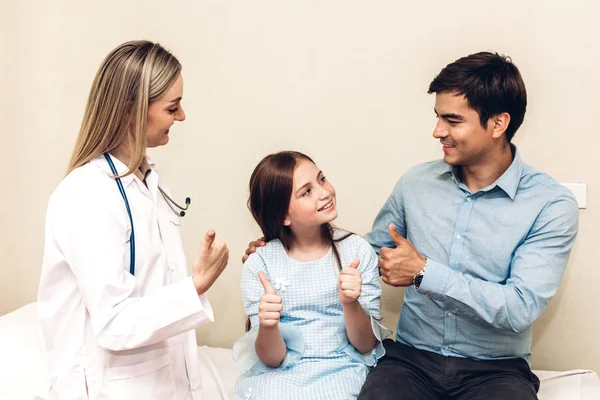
[366,147,578,361]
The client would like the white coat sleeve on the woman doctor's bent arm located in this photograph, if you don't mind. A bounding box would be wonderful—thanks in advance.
[48,184,213,351]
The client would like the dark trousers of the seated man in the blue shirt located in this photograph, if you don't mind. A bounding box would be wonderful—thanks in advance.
[358,339,540,400]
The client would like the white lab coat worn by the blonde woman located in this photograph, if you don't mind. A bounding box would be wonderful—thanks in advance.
[38,156,214,400]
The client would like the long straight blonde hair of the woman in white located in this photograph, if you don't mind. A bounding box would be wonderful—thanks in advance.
[67,40,181,176]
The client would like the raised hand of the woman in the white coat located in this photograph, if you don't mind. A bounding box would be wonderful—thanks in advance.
[192,229,229,294]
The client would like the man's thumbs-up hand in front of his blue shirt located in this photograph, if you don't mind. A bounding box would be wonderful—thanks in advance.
[378,224,427,286]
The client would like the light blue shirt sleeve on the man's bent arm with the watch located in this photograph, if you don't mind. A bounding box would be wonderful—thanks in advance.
[418,195,578,333]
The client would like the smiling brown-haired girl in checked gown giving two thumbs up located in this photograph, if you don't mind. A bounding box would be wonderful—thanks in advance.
[233,151,390,400]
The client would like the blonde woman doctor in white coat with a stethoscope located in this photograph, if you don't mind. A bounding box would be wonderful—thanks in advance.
[38,41,229,400]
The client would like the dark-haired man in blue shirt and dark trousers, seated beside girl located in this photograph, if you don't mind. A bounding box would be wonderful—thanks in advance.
[247,52,578,400]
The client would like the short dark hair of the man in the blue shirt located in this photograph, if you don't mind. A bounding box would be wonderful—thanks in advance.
[427,51,527,142]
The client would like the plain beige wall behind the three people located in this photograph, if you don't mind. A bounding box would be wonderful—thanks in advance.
[0,0,600,371]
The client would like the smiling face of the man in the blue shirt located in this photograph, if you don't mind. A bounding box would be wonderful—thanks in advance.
[433,92,496,166]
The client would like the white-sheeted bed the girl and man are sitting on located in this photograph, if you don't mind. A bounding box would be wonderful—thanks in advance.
[0,303,600,400]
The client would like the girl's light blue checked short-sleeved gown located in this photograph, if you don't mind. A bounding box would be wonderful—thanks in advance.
[233,230,391,400]
